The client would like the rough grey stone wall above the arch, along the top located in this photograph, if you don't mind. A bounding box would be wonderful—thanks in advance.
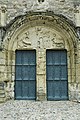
[0,0,80,23]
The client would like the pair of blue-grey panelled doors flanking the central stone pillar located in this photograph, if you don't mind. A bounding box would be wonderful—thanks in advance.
[15,50,68,100]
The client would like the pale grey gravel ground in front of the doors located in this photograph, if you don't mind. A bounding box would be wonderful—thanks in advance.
[0,100,80,120]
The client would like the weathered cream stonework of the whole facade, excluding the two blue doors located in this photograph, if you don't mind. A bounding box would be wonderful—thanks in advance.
[0,0,80,101]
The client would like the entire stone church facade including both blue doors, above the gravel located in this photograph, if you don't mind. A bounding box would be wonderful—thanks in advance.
[0,0,80,102]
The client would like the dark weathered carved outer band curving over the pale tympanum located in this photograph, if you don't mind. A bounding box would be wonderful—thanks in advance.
[2,11,78,48]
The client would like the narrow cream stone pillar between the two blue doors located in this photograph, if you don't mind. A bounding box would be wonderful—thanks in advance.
[37,50,46,101]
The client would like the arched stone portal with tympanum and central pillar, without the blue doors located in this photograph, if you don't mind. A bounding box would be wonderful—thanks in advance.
[3,12,77,100]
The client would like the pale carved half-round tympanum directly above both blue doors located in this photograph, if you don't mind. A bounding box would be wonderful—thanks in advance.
[17,26,65,51]
